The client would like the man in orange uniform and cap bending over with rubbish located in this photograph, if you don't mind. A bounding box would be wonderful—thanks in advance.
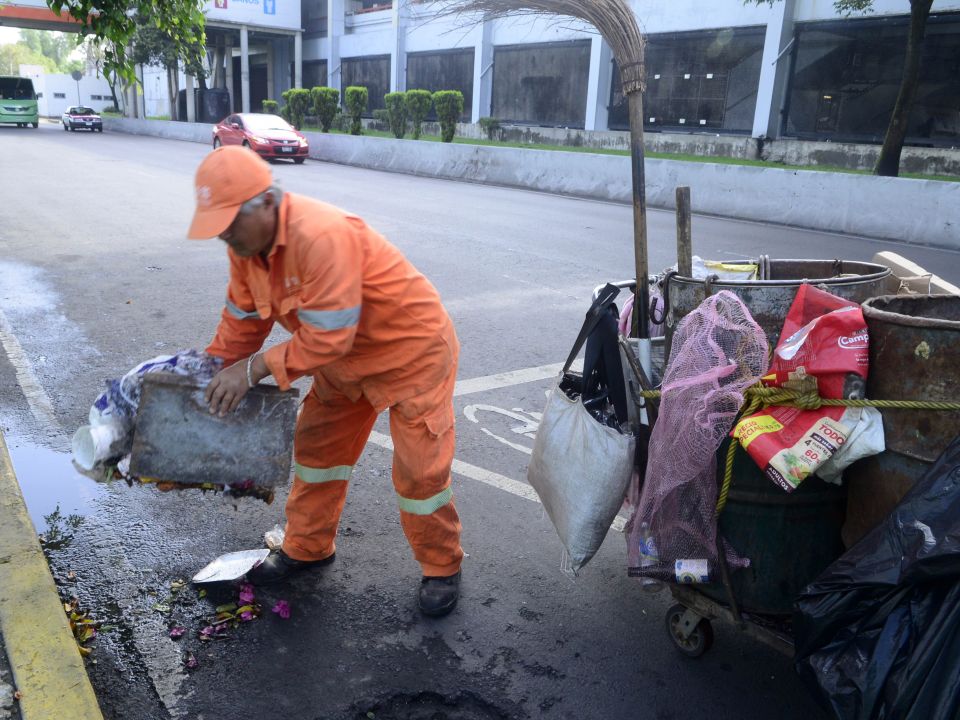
[188,146,463,616]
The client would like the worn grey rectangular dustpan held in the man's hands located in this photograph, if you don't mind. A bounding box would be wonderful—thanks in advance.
[130,372,299,487]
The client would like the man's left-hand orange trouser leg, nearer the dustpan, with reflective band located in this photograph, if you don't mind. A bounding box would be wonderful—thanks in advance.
[283,392,377,560]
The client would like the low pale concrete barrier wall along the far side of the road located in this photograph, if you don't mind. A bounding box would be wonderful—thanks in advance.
[104,118,960,249]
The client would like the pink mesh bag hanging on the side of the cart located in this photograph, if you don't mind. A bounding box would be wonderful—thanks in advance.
[627,291,768,583]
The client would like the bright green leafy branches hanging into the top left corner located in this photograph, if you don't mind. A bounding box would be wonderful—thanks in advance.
[47,0,206,83]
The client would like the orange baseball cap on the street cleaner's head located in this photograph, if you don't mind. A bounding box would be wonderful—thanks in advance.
[187,145,273,240]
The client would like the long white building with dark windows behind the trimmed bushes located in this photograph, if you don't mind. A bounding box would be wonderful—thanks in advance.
[135,0,960,145]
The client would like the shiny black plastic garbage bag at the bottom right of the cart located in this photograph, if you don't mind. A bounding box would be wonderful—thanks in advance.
[794,437,960,720]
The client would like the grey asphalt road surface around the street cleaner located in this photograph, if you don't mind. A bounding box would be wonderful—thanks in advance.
[0,124,960,720]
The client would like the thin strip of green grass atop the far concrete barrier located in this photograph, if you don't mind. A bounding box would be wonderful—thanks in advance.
[302,125,960,182]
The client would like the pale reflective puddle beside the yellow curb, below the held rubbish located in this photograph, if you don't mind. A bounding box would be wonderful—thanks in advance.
[5,437,103,533]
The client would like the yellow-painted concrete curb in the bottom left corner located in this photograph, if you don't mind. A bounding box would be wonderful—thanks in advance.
[0,433,103,720]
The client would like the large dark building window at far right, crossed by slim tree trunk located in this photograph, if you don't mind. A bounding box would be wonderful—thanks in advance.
[783,14,960,145]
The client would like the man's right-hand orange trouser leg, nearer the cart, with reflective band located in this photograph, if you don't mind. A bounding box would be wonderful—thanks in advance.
[390,369,463,577]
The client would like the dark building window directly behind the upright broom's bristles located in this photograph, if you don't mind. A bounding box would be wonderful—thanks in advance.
[608,27,764,132]
